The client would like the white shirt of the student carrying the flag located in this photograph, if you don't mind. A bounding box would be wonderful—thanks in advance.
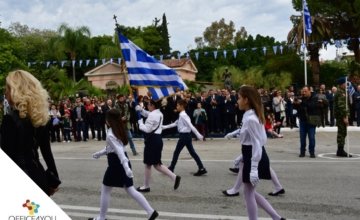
[138,109,164,134]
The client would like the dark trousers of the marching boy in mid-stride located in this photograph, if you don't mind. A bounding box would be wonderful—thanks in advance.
[170,133,204,170]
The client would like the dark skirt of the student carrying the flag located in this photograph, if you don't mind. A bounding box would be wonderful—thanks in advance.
[144,133,163,165]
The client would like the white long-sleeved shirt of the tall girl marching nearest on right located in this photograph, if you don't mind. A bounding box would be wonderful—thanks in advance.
[240,109,267,162]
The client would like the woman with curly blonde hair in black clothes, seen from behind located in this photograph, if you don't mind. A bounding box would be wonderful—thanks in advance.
[0,70,61,195]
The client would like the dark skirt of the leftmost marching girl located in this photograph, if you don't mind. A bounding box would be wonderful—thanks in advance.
[103,153,134,187]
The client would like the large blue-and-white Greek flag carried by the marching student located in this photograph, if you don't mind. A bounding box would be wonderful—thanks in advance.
[118,32,187,100]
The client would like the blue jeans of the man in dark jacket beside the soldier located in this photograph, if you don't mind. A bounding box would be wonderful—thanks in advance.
[300,121,316,154]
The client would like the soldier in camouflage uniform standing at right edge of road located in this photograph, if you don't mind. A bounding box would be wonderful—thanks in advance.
[334,77,352,157]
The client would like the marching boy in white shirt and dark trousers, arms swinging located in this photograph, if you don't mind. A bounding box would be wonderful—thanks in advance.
[162,99,207,176]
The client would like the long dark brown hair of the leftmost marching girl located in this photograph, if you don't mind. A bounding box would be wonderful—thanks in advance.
[106,108,128,145]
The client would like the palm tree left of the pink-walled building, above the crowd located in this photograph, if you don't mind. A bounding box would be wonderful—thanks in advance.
[58,24,91,82]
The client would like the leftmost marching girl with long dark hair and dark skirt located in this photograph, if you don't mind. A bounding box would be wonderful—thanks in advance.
[89,109,159,220]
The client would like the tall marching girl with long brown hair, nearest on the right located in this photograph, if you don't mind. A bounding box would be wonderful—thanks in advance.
[232,86,284,220]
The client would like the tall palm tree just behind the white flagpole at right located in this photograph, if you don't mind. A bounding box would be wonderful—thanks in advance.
[287,14,331,85]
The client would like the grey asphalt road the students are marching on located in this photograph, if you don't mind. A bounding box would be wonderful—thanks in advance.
[48,130,360,220]
